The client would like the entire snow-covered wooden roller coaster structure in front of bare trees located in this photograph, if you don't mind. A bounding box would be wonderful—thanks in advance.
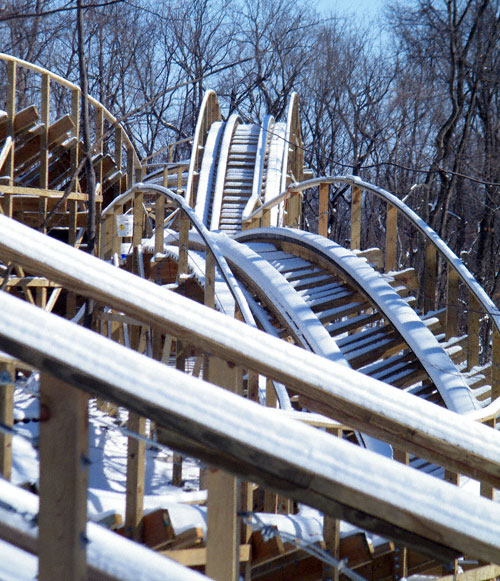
[0,55,500,581]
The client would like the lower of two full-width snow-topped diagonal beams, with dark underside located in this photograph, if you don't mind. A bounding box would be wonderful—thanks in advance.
[0,293,500,561]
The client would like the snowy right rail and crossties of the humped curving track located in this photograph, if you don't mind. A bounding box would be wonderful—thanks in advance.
[232,228,477,413]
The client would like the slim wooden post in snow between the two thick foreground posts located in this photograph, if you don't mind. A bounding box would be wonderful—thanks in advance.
[125,412,146,541]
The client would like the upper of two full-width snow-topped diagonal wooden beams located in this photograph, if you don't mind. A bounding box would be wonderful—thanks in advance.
[0,216,500,488]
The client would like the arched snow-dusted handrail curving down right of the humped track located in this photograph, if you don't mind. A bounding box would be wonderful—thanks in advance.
[248,175,500,333]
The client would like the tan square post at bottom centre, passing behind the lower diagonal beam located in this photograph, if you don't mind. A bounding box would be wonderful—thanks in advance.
[205,356,241,581]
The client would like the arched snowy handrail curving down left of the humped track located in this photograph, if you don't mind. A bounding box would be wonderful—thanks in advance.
[101,183,255,326]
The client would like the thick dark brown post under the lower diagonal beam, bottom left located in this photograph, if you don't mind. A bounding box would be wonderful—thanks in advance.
[38,374,89,581]
